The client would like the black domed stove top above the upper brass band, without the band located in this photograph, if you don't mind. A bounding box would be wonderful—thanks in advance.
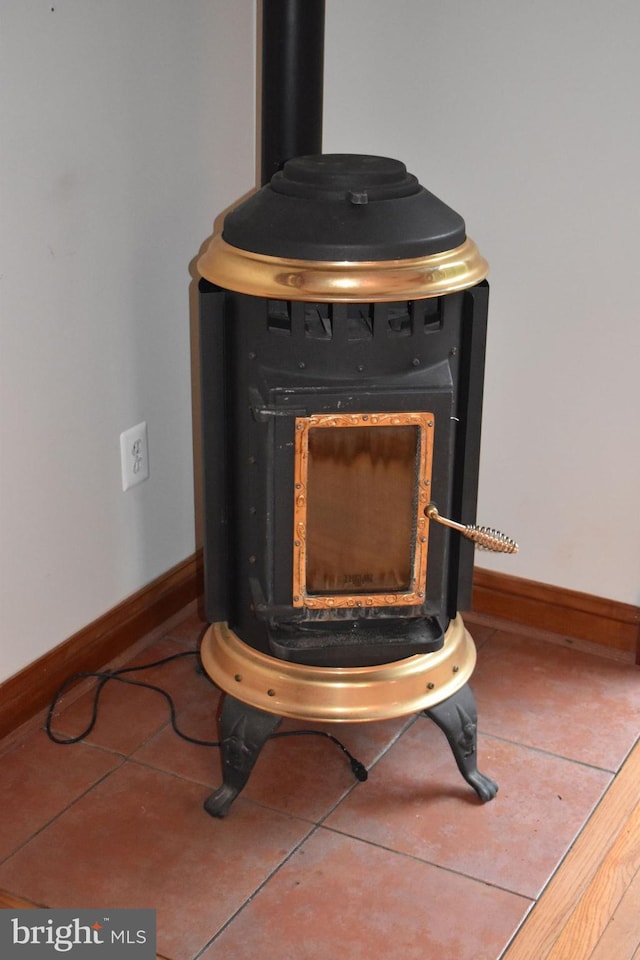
[222,154,466,261]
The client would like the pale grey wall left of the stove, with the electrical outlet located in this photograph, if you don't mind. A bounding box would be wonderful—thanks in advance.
[0,0,255,680]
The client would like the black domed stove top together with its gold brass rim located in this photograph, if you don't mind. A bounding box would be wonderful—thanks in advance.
[198,154,488,301]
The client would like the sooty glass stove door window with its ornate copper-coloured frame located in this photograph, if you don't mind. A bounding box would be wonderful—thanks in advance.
[294,414,433,607]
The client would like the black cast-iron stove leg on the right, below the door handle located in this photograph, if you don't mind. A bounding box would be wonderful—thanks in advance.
[424,684,498,803]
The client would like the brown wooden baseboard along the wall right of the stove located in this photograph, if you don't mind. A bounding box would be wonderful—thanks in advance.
[472,567,640,662]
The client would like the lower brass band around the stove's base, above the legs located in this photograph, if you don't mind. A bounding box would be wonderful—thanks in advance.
[201,615,476,723]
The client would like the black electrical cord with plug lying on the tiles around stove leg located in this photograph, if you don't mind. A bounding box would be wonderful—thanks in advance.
[45,650,369,781]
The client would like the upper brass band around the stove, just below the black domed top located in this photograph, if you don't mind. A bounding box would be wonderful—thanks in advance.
[198,235,489,303]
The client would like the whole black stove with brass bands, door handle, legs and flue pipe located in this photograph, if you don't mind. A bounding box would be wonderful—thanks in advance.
[199,2,515,816]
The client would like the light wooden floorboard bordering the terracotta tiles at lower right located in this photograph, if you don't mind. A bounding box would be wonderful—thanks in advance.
[502,743,640,960]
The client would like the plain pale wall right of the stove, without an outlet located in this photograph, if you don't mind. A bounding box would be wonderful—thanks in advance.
[324,0,640,604]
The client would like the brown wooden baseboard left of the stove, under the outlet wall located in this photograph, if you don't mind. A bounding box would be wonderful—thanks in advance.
[0,552,203,737]
